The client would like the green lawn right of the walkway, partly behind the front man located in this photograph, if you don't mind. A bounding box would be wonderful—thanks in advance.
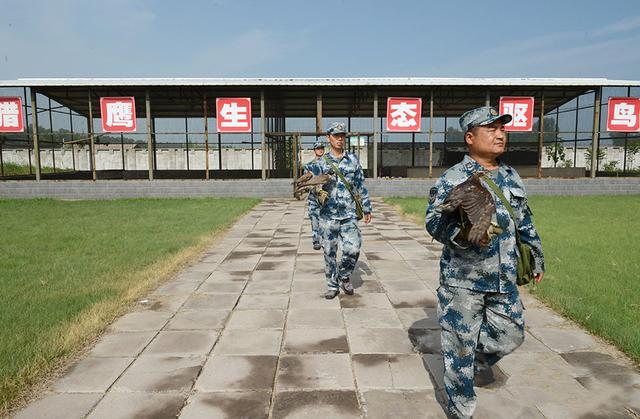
[385,195,640,362]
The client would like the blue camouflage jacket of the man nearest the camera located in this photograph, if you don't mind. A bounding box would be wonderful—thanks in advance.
[426,155,544,292]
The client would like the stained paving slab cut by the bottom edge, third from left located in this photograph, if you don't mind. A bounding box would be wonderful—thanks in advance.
[179,391,271,419]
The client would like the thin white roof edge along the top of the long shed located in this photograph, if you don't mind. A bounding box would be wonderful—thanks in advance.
[0,77,640,87]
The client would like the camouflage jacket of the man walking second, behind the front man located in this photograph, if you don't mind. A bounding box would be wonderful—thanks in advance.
[309,152,371,220]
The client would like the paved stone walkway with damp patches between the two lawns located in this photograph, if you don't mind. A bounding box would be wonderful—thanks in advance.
[18,200,640,419]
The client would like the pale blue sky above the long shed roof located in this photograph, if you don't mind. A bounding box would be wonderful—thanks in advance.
[0,0,640,80]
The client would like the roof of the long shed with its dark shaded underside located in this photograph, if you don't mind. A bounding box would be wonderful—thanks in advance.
[0,77,640,117]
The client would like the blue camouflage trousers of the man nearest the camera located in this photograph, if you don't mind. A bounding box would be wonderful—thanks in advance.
[438,285,524,418]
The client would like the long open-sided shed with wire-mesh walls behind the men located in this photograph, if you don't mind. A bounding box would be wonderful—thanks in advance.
[0,77,640,180]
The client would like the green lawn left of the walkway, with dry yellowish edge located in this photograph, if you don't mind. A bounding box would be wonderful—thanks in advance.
[0,198,258,416]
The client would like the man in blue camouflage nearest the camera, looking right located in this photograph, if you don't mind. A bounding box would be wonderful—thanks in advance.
[426,106,544,418]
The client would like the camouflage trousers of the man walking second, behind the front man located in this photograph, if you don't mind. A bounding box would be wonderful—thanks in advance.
[320,217,362,290]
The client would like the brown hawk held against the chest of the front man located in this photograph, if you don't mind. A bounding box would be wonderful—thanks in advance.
[440,172,502,246]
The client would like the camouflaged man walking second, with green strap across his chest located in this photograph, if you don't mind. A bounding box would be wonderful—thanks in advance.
[314,123,371,299]
